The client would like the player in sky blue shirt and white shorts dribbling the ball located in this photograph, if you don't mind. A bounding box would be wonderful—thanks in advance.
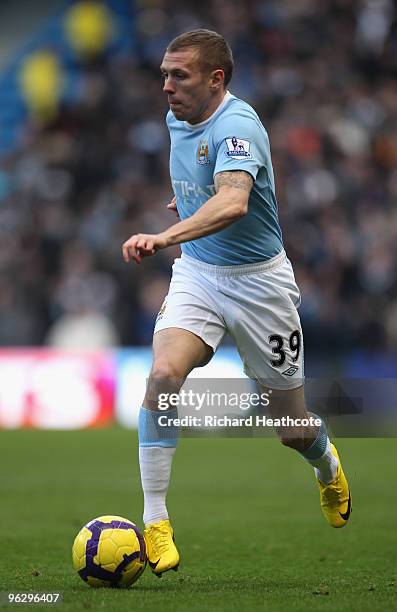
[123,29,351,576]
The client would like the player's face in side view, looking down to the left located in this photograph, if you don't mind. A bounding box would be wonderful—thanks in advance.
[160,49,217,123]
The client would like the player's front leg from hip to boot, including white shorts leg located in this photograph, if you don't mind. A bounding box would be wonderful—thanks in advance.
[139,257,225,575]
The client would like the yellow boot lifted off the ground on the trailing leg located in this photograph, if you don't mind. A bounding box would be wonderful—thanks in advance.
[317,444,352,527]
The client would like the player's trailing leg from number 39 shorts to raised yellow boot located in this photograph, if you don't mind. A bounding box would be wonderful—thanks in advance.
[224,260,351,527]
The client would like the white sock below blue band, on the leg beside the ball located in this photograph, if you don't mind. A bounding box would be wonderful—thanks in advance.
[139,446,176,525]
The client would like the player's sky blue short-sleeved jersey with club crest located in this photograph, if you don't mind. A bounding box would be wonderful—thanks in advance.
[167,92,283,266]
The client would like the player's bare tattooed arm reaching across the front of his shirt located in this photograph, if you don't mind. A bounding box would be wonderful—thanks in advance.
[123,170,254,263]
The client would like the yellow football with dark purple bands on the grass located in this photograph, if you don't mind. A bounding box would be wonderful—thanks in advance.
[72,515,147,587]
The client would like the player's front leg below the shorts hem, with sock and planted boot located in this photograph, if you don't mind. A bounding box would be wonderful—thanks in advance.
[138,328,213,576]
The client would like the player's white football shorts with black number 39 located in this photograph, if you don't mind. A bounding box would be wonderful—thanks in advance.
[154,251,303,389]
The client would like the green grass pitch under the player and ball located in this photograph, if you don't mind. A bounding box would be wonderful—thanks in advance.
[0,428,397,612]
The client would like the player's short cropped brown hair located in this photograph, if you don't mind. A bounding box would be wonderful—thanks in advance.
[166,29,234,87]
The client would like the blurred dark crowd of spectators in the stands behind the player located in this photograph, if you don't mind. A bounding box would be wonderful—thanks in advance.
[0,0,397,354]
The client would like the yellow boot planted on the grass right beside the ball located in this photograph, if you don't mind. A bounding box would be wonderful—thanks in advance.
[143,520,179,578]
